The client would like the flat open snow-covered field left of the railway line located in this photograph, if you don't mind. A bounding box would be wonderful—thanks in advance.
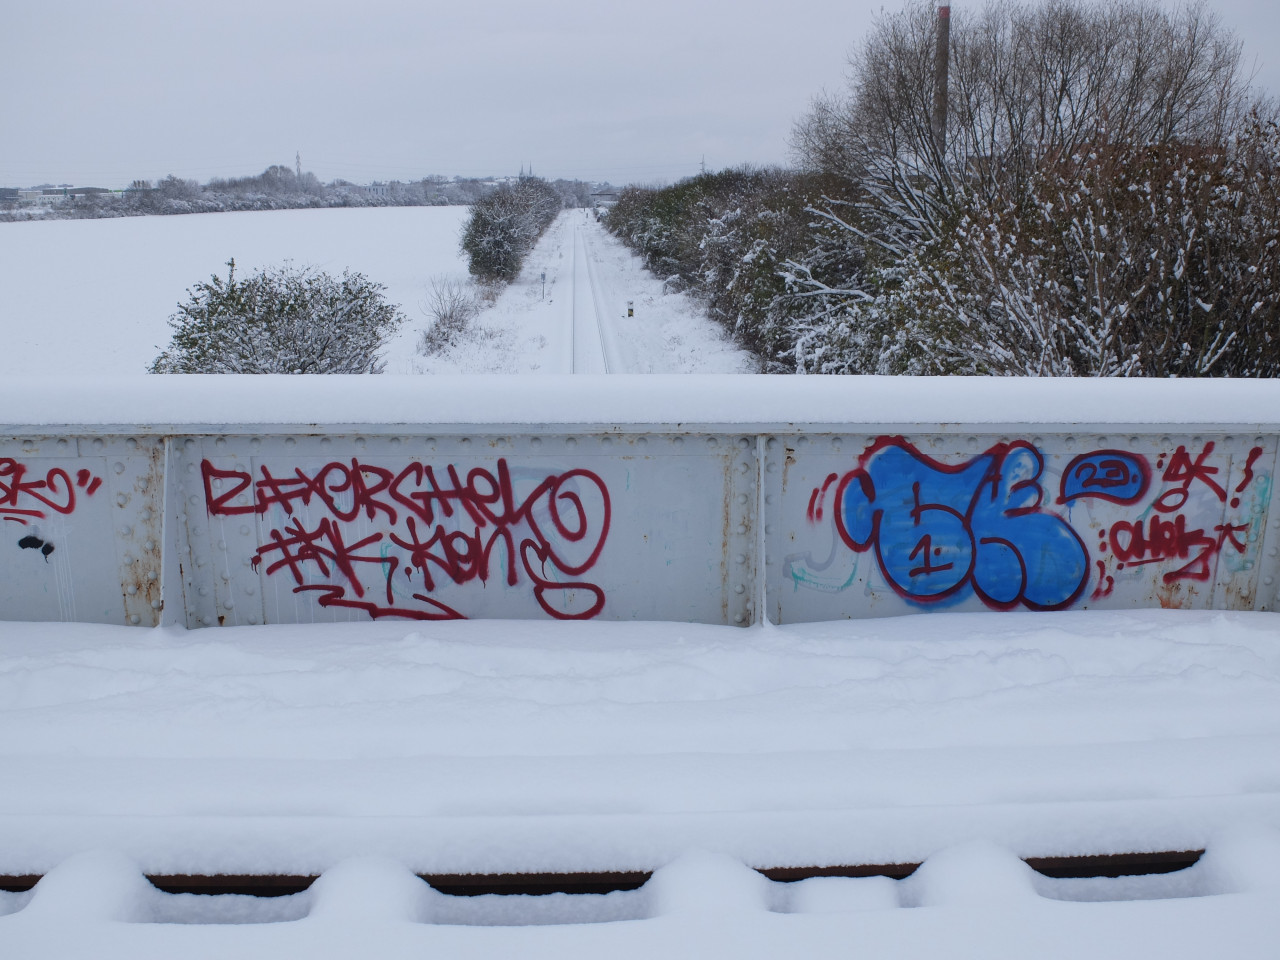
[0,206,467,375]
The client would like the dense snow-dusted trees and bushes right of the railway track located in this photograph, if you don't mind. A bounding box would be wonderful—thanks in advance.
[607,0,1280,376]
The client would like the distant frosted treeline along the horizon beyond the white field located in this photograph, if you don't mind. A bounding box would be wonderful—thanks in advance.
[0,165,604,220]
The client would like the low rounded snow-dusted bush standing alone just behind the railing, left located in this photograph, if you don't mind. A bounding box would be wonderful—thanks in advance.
[151,260,403,374]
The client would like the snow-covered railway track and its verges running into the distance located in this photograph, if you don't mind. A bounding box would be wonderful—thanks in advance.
[399,210,753,374]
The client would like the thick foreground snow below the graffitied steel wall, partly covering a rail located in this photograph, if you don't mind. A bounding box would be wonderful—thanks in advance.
[0,612,1280,957]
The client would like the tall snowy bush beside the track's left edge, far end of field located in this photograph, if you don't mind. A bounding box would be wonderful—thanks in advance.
[460,177,562,283]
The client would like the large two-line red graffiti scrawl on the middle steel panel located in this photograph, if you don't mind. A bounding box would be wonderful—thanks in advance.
[202,460,611,620]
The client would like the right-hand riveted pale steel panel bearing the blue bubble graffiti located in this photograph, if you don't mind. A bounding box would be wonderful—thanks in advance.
[765,433,1277,622]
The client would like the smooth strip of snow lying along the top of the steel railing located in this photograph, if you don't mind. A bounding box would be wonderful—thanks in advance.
[0,375,1280,435]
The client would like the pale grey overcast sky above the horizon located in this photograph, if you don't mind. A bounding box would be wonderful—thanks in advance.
[0,0,1280,187]
